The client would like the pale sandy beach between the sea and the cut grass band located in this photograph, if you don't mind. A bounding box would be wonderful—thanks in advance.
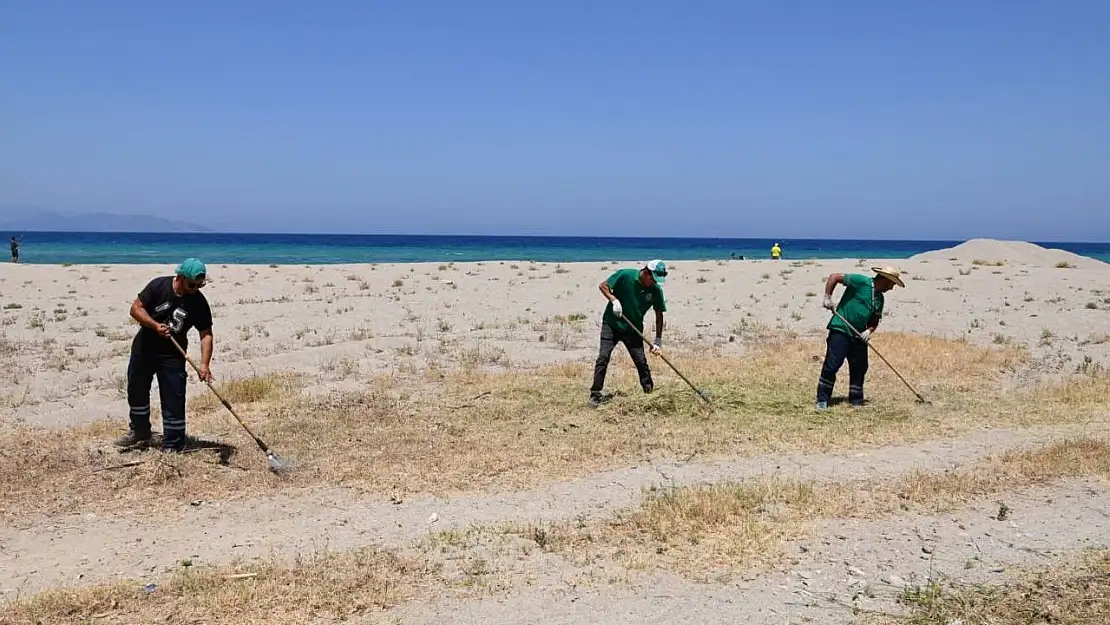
[0,241,1110,426]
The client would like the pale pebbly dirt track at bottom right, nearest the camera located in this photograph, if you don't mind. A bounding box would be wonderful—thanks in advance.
[391,480,1110,625]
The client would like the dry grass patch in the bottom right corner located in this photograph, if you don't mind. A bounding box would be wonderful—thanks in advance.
[871,550,1110,625]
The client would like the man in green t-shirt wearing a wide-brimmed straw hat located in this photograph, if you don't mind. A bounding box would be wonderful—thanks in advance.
[817,268,906,410]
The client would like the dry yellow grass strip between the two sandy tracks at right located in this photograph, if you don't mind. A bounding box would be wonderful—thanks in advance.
[529,440,1110,578]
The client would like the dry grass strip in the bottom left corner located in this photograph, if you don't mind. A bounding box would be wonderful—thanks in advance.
[0,550,440,625]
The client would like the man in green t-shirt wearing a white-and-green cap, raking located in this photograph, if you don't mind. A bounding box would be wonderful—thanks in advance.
[589,260,667,406]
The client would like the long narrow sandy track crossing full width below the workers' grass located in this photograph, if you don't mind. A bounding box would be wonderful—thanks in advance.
[0,419,1110,597]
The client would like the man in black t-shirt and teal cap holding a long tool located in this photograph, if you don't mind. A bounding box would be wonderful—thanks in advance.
[115,259,212,451]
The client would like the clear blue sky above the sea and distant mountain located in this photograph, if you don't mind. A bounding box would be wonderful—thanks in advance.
[0,0,1110,241]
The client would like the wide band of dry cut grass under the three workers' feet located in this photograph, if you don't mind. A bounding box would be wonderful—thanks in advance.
[0,333,1110,523]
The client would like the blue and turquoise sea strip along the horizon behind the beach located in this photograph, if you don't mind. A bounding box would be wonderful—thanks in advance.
[2,232,1110,264]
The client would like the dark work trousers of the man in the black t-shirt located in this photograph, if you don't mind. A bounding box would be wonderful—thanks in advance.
[128,353,188,450]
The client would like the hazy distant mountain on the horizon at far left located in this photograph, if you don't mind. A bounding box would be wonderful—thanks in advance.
[0,206,213,233]
